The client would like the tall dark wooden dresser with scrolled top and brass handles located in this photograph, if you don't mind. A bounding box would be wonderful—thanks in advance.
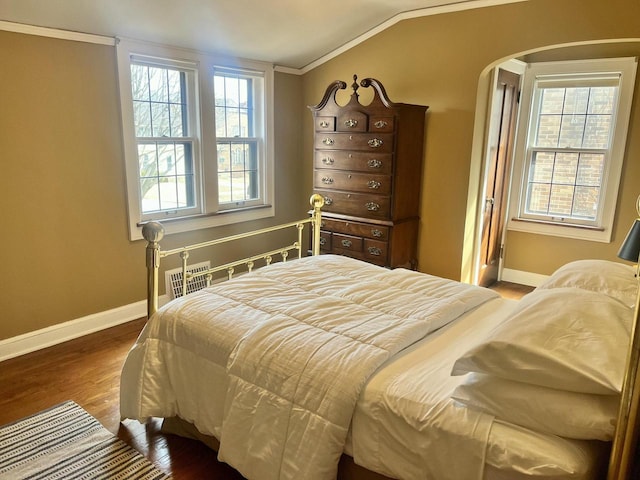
[309,75,428,269]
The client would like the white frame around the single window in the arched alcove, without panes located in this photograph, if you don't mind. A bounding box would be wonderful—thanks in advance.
[507,57,637,243]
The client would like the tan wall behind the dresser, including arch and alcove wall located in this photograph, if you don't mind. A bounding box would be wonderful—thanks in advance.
[304,0,640,279]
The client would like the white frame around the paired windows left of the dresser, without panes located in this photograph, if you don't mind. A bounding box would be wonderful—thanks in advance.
[116,39,275,240]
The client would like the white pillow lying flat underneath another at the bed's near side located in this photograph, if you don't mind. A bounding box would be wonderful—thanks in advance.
[452,374,620,441]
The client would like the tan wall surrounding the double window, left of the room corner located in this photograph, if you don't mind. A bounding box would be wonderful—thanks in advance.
[0,31,308,341]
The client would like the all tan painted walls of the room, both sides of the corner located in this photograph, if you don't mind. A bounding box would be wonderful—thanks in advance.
[0,0,640,340]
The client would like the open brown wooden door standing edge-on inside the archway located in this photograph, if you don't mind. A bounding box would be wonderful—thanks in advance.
[478,69,520,287]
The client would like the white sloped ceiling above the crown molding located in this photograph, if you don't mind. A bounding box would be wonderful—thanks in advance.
[0,0,523,69]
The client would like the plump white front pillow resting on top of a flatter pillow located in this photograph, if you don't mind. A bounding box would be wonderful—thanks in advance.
[452,288,633,395]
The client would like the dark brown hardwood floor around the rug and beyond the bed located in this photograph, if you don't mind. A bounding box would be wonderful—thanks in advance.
[0,282,532,480]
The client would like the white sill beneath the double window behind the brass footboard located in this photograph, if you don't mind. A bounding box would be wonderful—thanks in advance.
[130,205,275,240]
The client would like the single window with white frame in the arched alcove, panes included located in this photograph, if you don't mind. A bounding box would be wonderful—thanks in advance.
[509,59,636,242]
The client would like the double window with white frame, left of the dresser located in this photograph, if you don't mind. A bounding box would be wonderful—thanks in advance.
[118,40,274,239]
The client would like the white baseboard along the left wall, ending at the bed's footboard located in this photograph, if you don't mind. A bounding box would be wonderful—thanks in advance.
[0,300,147,362]
